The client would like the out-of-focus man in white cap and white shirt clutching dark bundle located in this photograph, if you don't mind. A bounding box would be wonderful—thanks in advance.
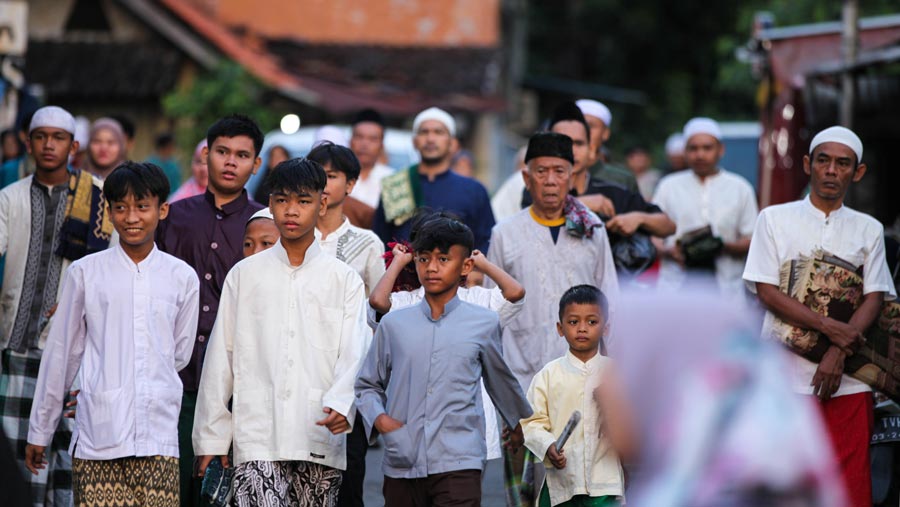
[653,118,758,301]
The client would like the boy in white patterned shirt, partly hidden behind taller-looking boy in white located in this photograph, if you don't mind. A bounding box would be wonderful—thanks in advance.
[307,141,384,296]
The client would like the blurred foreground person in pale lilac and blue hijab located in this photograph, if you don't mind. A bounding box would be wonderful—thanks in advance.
[596,286,846,507]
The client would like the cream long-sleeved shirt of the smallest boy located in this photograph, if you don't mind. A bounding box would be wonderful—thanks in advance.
[522,352,625,505]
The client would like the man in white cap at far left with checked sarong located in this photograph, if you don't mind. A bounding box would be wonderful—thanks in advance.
[0,106,112,505]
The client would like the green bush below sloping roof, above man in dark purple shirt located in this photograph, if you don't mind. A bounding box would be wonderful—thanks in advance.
[163,60,278,153]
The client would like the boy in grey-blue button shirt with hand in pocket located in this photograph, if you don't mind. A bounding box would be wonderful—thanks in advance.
[356,217,531,507]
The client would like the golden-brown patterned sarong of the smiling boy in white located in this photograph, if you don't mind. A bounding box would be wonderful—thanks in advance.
[72,456,179,507]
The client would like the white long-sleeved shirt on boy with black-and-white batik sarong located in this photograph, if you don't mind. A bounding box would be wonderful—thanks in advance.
[193,241,372,469]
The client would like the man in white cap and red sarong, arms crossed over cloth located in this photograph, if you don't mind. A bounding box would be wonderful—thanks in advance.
[744,127,896,507]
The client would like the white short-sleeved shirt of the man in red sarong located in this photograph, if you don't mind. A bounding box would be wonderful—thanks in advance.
[744,197,897,396]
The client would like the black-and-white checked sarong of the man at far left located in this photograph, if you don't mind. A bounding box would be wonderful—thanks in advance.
[0,349,74,507]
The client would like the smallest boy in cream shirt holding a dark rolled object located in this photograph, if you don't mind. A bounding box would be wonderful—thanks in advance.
[522,285,624,507]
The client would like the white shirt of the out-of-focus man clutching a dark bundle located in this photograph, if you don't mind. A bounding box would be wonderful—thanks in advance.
[653,169,758,299]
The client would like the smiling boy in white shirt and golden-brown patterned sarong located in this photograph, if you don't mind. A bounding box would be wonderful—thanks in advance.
[26,162,200,506]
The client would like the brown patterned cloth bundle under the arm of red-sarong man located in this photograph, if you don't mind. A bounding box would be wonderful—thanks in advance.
[772,249,900,400]
